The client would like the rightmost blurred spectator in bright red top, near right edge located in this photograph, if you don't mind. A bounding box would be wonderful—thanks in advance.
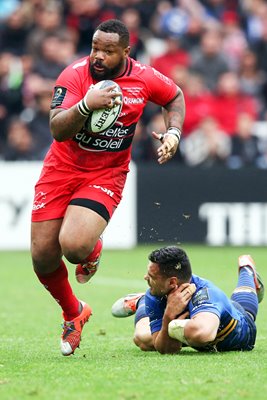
[213,72,259,135]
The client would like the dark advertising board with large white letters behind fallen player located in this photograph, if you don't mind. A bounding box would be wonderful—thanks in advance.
[137,164,267,246]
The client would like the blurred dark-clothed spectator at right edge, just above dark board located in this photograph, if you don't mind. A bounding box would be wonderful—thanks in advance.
[227,113,267,169]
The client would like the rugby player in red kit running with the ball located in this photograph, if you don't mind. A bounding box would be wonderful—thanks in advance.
[31,20,185,356]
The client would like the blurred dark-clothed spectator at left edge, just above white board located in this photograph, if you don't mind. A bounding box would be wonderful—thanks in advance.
[2,117,36,161]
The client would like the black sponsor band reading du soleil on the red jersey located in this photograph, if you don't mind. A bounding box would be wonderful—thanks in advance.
[73,124,136,152]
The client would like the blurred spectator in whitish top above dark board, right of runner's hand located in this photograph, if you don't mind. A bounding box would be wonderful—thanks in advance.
[181,117,231,167]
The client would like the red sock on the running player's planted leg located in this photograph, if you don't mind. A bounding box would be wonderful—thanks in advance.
[36,260,80,321]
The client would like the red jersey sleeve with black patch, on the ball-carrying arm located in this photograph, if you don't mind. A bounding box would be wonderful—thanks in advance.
[51,59,88,109]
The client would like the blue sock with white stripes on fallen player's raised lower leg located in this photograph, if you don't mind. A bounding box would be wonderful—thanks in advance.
[231,267,258,320]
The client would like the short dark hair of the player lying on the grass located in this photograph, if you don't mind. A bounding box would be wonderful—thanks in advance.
[148,246,192,283]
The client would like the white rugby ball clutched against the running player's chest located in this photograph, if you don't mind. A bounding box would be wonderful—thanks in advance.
[84,80,122,133]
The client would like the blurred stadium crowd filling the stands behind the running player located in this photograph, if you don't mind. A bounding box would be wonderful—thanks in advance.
[0,0,267,168]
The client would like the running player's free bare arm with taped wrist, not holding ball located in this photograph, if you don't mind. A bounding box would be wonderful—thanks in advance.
[152,87,185,164]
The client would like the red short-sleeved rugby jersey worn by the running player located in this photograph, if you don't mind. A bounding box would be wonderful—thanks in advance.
[45,57,178,172]
